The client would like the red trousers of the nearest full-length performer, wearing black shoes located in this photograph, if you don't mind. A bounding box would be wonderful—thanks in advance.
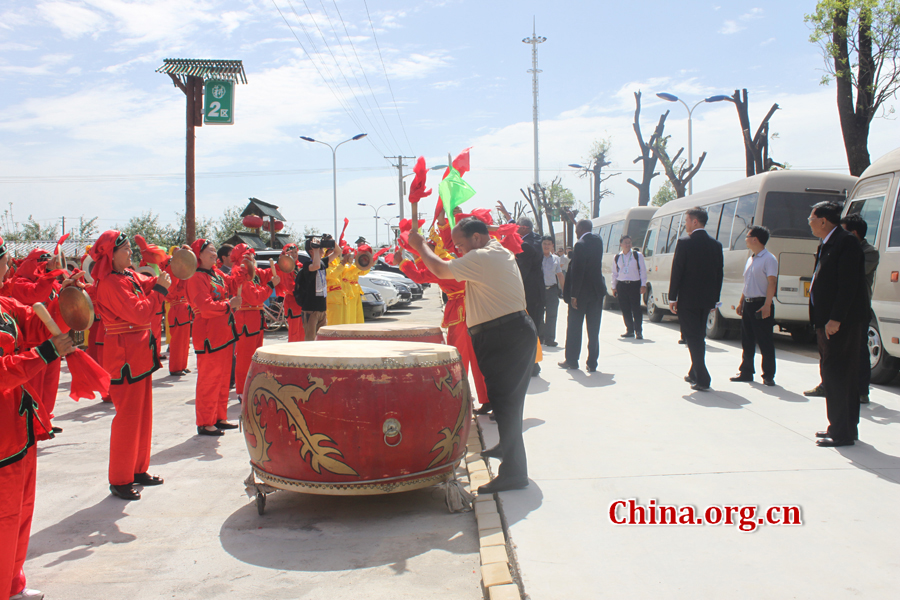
[109,376,153,485]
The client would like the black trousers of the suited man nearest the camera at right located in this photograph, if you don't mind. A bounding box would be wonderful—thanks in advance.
[816,323,867,442]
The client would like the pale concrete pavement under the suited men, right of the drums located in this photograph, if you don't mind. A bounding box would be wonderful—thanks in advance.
[479,307,900,600]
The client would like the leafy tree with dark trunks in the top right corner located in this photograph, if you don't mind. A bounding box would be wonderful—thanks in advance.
[804,0,900,176]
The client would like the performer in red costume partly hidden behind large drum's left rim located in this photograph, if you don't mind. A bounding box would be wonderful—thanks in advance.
[228,244,281,399]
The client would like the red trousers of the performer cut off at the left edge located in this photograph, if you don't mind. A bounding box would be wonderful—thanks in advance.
[0,446,36,598]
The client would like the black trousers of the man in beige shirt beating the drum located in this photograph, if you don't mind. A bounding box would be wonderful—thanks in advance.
[472,315,537,479]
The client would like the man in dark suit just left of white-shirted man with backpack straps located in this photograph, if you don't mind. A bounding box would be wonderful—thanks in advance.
[559,219,606,373]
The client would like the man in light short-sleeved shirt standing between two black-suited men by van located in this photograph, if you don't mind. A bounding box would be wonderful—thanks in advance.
[731,225,778,386]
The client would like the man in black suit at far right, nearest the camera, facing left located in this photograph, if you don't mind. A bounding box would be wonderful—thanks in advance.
[809,202,870,447]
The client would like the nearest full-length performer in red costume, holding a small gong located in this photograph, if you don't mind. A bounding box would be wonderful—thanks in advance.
[91,230,171,500]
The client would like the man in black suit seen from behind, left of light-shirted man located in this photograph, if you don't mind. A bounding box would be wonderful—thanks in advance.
[669,207,724,392]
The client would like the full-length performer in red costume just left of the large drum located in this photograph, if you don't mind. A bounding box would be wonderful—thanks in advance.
[187,239,241,435]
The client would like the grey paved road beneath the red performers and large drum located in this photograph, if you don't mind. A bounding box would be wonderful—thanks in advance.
[26,291,482,600]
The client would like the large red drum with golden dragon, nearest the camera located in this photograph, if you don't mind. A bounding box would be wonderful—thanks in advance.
[242,340,472,495]
